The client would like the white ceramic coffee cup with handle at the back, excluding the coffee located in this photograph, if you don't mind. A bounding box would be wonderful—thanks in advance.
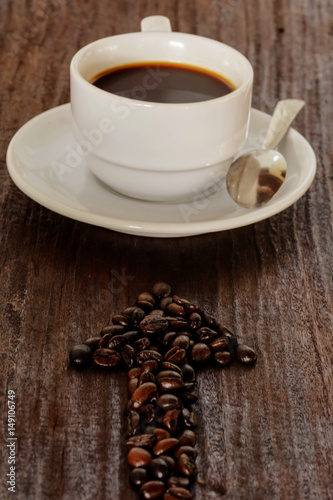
[70,16,253,201]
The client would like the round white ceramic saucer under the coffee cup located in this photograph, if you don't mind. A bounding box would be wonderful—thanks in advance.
[7,104,316,238]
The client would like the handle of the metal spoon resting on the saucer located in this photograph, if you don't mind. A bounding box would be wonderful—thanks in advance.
[263,99,305,149]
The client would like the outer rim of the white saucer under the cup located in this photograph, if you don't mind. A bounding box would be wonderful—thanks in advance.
[6,103,317,238]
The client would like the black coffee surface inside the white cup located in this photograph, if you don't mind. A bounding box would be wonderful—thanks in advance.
[92,63,235,103]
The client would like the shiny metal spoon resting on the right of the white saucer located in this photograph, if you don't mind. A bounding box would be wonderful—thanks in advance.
[226,99,305,208]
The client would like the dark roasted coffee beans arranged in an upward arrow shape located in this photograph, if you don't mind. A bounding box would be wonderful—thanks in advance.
[70,282,256,500]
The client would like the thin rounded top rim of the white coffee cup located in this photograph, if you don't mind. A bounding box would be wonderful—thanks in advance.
[70,31,254,109]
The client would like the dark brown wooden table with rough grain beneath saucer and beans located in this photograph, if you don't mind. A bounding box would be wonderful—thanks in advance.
[0,0,333,500]
